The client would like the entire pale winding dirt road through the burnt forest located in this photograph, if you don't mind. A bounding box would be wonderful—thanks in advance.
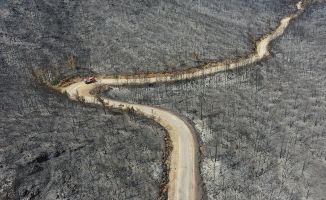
[62,2,304,200]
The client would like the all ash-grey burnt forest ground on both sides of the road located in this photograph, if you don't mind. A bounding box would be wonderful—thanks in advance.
[0,0,326,200]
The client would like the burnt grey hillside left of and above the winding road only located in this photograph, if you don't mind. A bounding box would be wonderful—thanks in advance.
[0,0,306,199]
